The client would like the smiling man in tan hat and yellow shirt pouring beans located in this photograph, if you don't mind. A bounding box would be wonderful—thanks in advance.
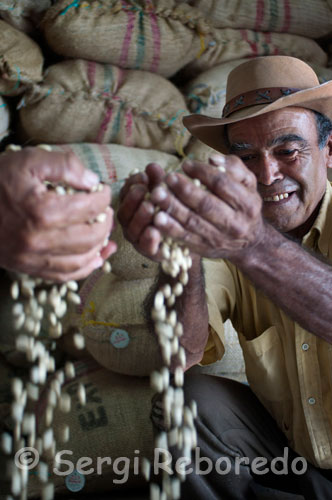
[119,56,332,499]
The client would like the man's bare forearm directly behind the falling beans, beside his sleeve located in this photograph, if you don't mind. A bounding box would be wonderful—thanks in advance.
[145,256,208,369]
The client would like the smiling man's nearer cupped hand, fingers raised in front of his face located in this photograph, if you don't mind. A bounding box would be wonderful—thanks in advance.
[151,156,264,259]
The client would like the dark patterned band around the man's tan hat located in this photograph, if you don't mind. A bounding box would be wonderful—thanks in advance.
[222,87,301,118]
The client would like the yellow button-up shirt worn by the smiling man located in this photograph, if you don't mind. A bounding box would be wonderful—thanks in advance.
[201,183,332,469]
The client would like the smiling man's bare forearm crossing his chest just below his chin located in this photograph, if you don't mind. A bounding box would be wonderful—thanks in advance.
[230,224,332,343]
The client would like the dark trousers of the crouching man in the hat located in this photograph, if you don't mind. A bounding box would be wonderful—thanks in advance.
[151,375,332,500]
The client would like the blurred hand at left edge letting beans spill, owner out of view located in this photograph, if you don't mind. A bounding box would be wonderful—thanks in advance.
[0,148,116,281]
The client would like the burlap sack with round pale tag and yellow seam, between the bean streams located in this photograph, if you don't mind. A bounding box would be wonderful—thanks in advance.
[65,271,161,376]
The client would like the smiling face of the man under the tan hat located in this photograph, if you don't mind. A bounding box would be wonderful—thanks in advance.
[228,107,330,232]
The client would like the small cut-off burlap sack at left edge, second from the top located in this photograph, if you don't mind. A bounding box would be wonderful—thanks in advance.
[0,20,43,95]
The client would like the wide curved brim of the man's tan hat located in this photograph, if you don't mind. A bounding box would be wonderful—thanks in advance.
[183,80,332,153]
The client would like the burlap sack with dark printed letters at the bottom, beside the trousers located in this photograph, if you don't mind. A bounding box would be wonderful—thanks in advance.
[25,361,153,498]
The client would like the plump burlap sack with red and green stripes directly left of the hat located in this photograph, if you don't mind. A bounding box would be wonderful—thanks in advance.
[20,60,189,153]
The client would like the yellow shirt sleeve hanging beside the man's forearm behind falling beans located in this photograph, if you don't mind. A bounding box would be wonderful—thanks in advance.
[200,259,236,365]
